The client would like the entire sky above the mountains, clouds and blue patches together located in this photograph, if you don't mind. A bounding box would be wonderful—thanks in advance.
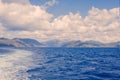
[0,0,120,43]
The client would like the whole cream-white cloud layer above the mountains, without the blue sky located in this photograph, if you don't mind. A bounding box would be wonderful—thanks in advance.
[0,0,120,42]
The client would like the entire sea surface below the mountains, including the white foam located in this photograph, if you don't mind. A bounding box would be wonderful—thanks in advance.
[0,48,120,80]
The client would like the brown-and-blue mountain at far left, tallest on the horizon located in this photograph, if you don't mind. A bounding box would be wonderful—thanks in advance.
[0,38,43,47]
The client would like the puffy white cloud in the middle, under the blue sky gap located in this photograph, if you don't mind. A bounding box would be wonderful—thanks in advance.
[52,13,84,32]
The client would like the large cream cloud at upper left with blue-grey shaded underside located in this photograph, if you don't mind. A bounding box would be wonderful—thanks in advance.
[0,3,53,30]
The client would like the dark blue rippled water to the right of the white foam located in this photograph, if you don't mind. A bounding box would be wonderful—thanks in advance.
[27,48,120,80]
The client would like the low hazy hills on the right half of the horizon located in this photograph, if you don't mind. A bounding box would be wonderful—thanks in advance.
[62,41,120,47]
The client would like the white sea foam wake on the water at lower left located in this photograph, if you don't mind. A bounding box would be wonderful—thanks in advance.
[0,50,34,80]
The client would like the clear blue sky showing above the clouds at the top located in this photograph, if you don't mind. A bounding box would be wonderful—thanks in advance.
[30,0,119,17]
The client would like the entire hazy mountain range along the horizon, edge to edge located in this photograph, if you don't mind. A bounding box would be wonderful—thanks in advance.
[0,38,120,48]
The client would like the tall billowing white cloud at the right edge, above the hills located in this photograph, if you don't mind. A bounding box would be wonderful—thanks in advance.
[84,7,120,42]
